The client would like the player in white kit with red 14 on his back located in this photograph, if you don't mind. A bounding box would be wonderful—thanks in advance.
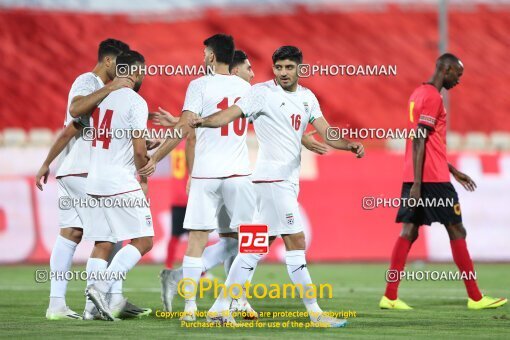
[84,51,154,321]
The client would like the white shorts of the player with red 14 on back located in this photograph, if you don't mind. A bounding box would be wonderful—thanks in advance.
[83,190,154,242]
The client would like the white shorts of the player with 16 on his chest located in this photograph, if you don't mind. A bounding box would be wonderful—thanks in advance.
[254,181,304,236]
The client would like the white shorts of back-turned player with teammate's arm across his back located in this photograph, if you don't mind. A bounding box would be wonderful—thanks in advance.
[184,176,255,232]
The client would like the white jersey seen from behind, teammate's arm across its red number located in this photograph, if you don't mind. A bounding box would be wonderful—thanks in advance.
[183,74,250,178]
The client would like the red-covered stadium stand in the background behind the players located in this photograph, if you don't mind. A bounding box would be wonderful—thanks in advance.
[0,5,510,137]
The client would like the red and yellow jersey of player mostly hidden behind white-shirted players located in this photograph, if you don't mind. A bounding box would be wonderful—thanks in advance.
[170,140,188,207]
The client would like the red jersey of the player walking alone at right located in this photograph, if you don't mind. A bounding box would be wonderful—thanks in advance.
[404,84,450,183]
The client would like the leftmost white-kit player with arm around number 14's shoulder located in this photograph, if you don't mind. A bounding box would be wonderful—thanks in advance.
[36,39,133,320]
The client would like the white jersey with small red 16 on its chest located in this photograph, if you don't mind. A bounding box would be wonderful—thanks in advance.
[236,80,322,184]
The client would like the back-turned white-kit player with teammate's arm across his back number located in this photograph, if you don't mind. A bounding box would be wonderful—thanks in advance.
[140,34,255,321]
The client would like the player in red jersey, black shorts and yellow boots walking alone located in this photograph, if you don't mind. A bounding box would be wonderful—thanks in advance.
[379,53,507,309]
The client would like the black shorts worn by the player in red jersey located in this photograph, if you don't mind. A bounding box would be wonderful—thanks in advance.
[397,182,462,226]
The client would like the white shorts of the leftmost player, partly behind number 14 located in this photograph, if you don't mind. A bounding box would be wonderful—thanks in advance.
[57,176,88,229]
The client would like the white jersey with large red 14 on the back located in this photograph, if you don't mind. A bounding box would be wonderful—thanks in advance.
[87,88,148,195]
